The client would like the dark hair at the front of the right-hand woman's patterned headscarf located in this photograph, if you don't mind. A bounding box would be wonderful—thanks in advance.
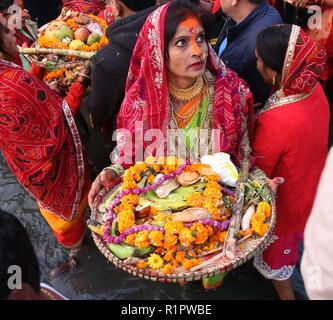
[257,24,292,72]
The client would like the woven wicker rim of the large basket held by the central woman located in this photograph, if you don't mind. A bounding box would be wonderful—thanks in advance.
[91,170,276,283]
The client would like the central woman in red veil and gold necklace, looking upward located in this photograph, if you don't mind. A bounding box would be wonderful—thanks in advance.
[89,1,252,287]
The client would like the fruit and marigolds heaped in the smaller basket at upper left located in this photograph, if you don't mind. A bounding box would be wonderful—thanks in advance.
[22,9,108,95]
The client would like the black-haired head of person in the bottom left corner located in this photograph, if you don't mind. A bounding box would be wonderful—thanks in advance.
[0,210,40,300]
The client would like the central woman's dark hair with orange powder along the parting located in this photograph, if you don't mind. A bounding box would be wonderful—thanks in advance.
[164,0,202,60]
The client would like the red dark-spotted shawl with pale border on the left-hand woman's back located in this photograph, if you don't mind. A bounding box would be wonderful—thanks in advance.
[0,60,84,221]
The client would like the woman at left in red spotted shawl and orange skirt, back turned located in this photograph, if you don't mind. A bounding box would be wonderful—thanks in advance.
[0,24,89,254]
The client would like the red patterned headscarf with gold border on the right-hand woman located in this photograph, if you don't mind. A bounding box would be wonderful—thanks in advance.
[261,25,327,113]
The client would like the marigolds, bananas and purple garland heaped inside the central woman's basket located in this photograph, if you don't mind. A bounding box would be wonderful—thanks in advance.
[88,157,271,275]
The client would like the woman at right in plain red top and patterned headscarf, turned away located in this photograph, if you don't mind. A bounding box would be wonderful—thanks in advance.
[253,25,330,299]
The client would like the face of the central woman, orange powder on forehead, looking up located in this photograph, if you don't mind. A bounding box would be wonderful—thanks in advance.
[167,17,208,88]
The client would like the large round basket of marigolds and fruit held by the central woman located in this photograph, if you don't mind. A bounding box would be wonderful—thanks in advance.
[88,153,276,282]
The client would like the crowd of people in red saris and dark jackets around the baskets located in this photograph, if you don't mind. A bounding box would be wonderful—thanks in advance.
[0,0,333,299]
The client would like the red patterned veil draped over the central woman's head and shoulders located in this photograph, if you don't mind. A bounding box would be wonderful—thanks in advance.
[117,4,252,166]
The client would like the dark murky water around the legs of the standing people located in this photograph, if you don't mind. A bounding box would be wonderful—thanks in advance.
[0,120,276,300]
